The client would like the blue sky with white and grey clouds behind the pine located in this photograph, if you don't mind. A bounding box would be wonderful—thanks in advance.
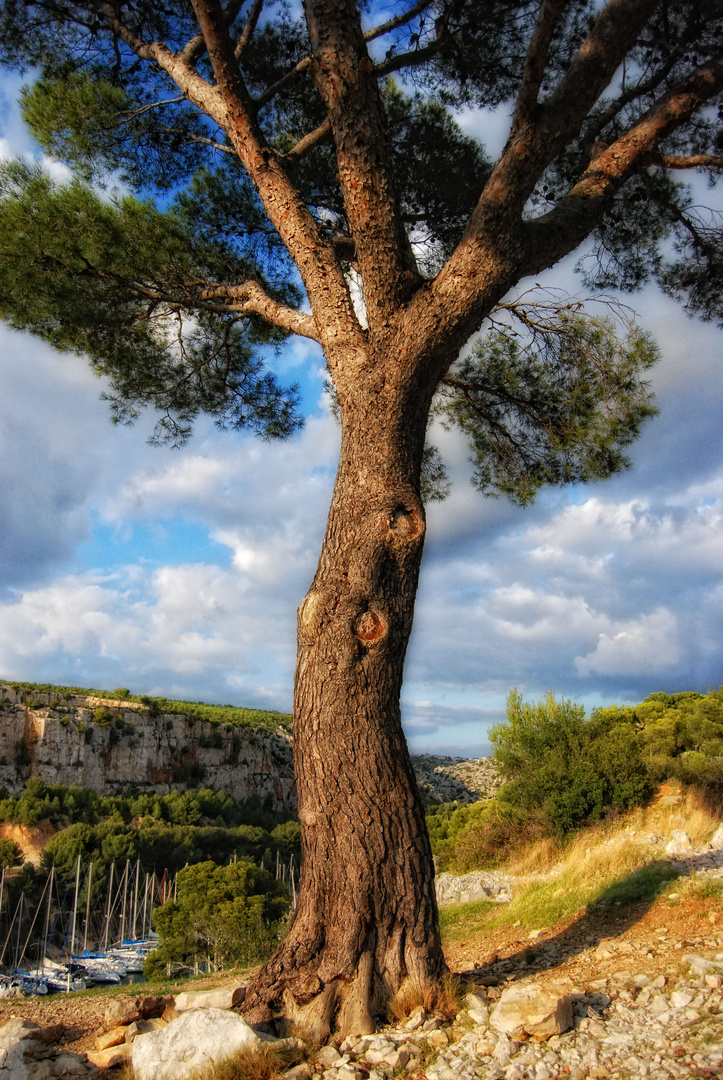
[0,69,723,757]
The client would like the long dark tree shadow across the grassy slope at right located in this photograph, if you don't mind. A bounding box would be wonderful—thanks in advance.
[459,856,710,985]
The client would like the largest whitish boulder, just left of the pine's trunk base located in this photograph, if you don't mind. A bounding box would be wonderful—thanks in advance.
[132,1009,260,1080]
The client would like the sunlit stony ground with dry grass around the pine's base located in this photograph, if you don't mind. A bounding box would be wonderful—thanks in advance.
[0,870,723,1080]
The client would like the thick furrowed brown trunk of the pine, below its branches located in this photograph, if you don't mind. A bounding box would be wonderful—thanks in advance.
[244,367,445,1041]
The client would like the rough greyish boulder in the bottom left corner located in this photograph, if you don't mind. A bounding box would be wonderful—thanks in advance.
[0,1018,97,1080]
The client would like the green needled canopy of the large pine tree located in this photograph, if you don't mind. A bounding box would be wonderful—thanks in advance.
[0,0,723,481]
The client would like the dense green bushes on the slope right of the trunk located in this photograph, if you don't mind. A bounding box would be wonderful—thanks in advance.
[427,689,723,873]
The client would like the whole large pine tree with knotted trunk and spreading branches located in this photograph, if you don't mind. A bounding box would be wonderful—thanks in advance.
[0,0,723,1039]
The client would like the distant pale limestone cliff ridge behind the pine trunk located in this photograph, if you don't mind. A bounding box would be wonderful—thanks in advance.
[0,685,501,813]
